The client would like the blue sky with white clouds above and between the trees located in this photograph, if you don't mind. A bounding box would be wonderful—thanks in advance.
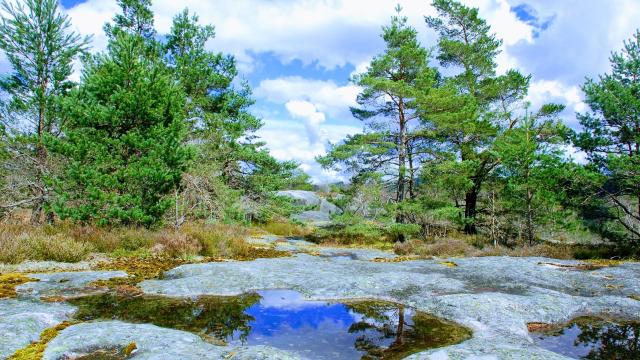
[0,0,640,183]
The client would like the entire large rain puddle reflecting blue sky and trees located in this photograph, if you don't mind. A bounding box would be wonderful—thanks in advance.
[72,290,471,359]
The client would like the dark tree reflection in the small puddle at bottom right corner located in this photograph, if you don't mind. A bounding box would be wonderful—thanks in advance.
[572,319,640,360]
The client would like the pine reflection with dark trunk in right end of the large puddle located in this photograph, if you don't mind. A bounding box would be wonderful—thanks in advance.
[347,302,471,359]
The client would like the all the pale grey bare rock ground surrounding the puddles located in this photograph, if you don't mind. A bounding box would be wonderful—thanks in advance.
[0,237,640,359]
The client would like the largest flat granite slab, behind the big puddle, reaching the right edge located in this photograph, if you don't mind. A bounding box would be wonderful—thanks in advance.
[141,255,640,359]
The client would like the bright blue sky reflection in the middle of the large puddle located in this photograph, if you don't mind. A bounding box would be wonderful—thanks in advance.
[230,290,400,359]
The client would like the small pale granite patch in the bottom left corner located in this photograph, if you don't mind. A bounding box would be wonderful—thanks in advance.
[0,299,75,359]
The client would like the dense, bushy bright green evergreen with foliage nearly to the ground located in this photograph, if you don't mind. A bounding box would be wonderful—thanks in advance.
[53,32,191,226]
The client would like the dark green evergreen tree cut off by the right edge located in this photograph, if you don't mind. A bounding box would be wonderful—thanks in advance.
[575,31,640,240]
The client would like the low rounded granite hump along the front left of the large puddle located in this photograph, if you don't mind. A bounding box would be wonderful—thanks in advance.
[43,321,301,360]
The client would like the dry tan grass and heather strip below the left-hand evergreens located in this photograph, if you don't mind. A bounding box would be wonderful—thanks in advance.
[0,222,268,264]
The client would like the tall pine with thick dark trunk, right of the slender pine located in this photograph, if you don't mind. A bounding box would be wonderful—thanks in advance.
[421,0,529,233]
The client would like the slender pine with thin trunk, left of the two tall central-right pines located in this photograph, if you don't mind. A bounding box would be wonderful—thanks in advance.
[318,7,437,240]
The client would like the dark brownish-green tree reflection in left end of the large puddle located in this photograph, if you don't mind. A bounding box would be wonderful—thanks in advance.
[71,293,260,341]
